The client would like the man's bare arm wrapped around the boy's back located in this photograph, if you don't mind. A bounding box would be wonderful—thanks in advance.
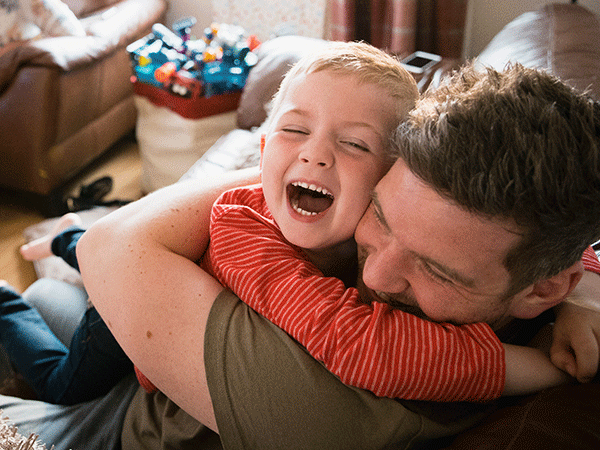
[77,168,258,430]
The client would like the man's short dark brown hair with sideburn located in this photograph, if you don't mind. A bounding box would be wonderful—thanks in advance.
[394,64,600,295]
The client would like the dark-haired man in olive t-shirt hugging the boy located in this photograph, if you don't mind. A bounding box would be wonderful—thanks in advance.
[1,62,600,449]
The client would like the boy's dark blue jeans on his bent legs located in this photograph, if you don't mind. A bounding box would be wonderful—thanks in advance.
[0,229,133,405]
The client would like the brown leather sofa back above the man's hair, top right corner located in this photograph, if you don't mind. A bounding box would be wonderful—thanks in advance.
[476,4,600,99]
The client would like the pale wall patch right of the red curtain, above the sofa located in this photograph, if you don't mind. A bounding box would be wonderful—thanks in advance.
[463,0,600,58]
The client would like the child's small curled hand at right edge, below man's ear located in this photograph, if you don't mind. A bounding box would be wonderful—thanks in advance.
[550,271,600,383]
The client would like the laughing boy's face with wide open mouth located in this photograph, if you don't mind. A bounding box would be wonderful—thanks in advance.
[262,71,397,250]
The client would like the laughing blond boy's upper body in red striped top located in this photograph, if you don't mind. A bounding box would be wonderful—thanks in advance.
[0,43,596,402]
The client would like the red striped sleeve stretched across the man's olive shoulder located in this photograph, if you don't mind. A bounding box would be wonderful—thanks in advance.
[203,186,505,401]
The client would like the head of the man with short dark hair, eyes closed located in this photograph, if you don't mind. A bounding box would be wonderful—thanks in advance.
[355,62,600,348]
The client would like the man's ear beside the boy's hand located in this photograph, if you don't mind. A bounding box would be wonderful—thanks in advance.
[511,261,584,319]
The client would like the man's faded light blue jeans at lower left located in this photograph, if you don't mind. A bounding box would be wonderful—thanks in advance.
[0,279,139,450]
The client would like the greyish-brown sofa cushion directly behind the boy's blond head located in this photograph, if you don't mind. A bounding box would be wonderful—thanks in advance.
[237,36,327,130]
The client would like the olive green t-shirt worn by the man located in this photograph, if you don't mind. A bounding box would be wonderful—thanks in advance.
[123,291,492,450]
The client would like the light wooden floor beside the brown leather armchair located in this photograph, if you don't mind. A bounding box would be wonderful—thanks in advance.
[0,136,142,291]
